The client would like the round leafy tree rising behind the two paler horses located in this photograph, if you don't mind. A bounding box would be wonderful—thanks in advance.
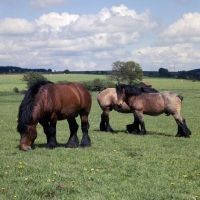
[109,61,143,85]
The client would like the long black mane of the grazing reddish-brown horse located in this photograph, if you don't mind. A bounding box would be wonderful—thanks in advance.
[17,80,53,133]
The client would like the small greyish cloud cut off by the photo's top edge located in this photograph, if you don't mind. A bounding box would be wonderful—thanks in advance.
[30,0,67,9]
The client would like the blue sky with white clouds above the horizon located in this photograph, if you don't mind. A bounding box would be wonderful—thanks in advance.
[0,0,200,71]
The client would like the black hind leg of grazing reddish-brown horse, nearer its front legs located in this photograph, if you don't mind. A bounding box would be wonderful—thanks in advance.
[65,117,79,148]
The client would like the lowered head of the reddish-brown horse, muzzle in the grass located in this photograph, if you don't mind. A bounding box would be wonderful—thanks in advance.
[18,125,37,151]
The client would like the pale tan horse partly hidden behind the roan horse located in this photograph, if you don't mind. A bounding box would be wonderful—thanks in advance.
[97,87,158,132]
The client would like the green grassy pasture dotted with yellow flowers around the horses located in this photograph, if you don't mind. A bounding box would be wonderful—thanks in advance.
[0,75,200,200]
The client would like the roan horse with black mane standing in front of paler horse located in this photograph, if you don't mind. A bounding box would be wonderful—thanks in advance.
[116,85,191,137]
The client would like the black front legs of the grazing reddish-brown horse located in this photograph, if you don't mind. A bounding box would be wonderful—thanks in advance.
[40,121,57,149]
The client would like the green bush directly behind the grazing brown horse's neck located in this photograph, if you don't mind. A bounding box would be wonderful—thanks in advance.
[21,72,47,88]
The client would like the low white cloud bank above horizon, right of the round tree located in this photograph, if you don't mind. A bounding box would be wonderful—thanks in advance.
[132,43,200,71]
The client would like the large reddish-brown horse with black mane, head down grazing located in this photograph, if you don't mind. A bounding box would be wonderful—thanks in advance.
[17,80,92,150]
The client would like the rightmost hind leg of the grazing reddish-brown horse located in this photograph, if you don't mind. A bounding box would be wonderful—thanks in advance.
[80,115,91,147]
